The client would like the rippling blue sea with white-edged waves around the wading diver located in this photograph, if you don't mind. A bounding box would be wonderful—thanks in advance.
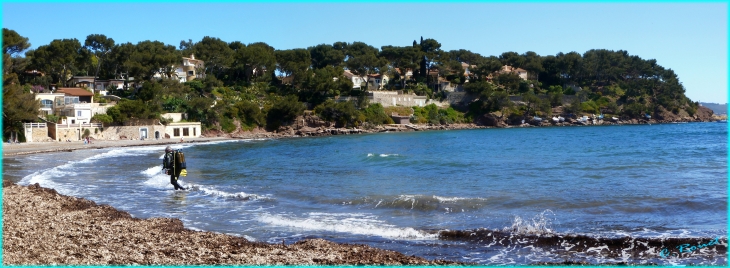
[3,123,728,265]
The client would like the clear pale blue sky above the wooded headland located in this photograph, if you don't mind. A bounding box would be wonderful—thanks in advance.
[2,1,728,103]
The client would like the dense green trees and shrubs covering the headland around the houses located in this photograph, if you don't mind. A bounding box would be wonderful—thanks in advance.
[3,28,698,137]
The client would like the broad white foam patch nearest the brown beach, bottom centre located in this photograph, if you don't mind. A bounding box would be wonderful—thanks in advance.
[257,213,438,240]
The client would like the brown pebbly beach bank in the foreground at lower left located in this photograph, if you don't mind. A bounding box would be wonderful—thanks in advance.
[3,181,458,265]
